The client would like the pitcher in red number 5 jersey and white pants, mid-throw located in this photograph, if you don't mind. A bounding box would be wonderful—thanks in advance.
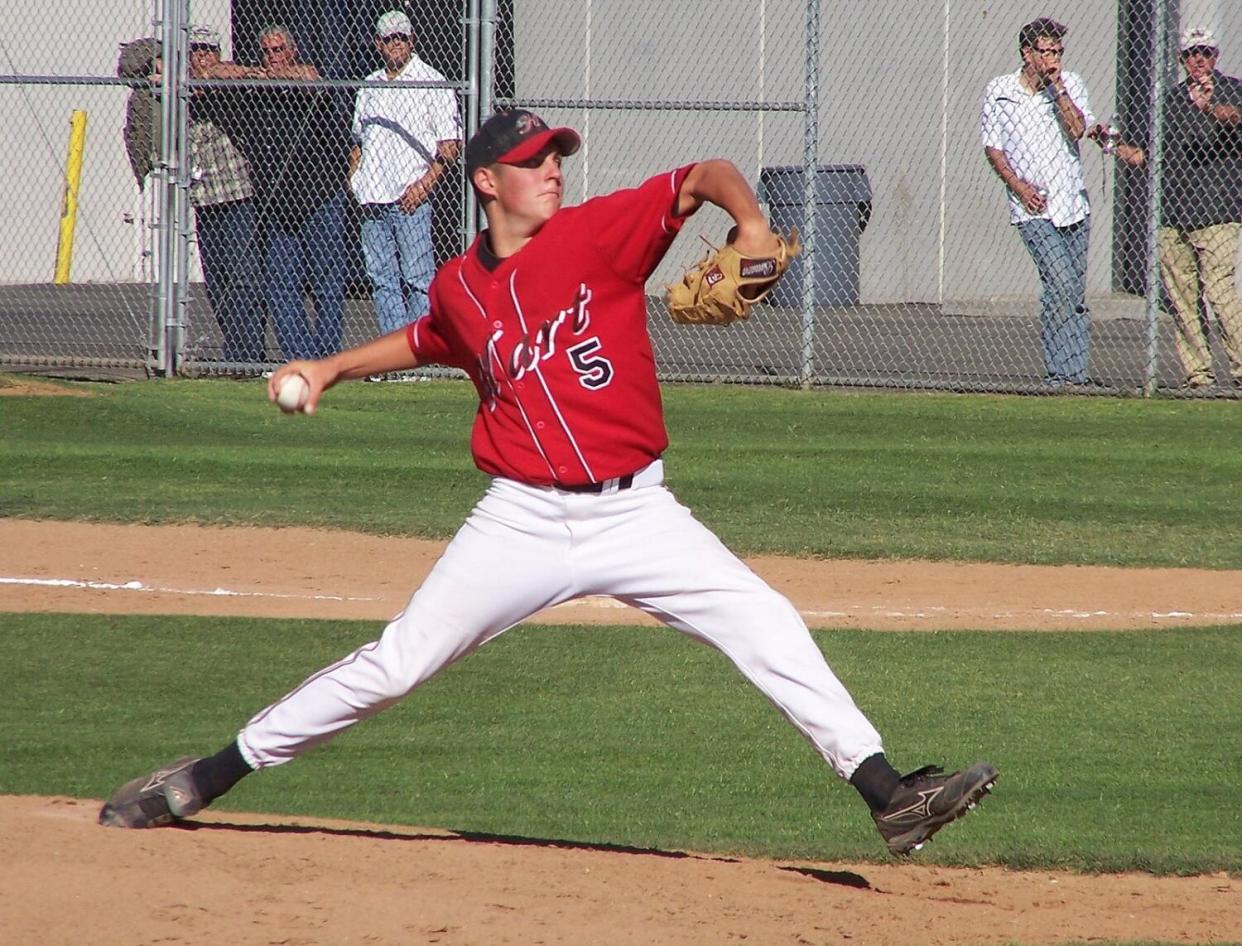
[99,109,997,854]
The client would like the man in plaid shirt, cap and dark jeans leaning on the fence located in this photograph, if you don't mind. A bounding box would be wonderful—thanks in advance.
[189,26,267,363]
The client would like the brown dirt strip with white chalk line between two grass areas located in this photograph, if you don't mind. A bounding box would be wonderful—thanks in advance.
[0,519,1242,631]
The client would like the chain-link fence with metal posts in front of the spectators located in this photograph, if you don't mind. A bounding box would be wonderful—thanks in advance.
[0,0,1242,397]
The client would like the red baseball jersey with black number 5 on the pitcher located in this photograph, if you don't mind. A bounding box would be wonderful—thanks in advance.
[406,165,693,485]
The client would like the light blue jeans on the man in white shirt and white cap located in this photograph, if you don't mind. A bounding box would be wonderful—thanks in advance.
[361,202,436,335]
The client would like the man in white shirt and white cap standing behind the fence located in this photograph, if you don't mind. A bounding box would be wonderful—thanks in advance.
[349,10,461,334]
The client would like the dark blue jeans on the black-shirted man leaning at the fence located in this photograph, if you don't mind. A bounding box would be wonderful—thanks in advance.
[263,191,345,361]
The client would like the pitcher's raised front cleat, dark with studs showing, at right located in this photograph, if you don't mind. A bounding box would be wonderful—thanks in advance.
[871,762,1000,855]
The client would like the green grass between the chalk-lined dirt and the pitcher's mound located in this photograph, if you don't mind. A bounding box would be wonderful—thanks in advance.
[0,615,1242,874]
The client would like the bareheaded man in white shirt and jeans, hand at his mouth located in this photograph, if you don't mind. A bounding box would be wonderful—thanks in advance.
[980,16,1095,389]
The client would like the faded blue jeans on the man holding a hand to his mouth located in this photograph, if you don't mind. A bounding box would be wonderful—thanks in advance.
[1017,217,1090,385]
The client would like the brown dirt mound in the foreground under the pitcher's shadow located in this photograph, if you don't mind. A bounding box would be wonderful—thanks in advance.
[0,796,1242,946]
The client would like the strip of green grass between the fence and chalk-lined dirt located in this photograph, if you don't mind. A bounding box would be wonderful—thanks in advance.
[0,381,1242,569]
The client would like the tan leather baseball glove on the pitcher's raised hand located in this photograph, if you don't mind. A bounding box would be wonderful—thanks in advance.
[664,228,802,325]
